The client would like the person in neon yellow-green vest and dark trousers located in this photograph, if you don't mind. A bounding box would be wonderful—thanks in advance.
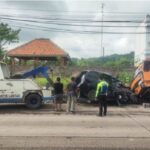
[96,80,109,116]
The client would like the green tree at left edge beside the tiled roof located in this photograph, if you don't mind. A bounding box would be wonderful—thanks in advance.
[0,23,20,59]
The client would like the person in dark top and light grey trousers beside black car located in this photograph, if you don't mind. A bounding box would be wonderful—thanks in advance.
[67,77,77,113]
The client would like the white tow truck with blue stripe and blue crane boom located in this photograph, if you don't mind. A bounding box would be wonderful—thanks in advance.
[0,62,54,109]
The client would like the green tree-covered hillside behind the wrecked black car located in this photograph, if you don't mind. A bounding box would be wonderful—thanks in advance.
[71,52,134,70]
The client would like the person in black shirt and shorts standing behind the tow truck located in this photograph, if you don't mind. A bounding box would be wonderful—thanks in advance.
[54,77,63,111]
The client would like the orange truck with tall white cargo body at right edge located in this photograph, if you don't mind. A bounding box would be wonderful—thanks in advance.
[130,15,150,102]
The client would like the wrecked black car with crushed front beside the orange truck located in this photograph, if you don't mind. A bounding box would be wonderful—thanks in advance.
[76,71,133,105]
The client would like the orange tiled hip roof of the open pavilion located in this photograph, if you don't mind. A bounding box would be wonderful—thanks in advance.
[7,39,68,57]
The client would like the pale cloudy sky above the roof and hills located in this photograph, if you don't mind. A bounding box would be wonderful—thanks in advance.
[0,0,150,58]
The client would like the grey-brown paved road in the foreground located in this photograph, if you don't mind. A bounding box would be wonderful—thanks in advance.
[0,105,150,150]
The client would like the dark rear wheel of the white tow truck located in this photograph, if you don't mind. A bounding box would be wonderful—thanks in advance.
[25,94,42,109]
